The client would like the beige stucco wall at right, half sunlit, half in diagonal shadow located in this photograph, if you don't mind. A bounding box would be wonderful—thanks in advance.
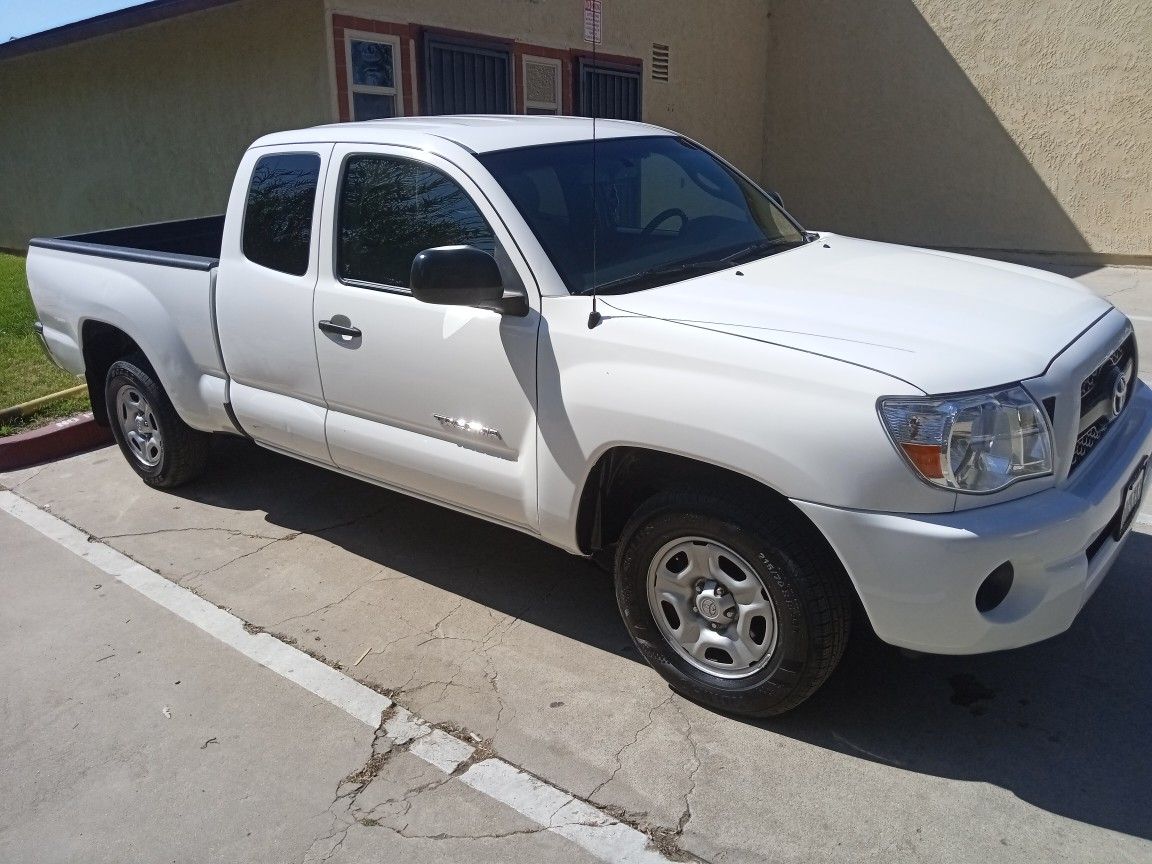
[764,0,1152,263]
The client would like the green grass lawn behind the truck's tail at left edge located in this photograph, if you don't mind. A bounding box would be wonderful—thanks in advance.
[0,253,88,435]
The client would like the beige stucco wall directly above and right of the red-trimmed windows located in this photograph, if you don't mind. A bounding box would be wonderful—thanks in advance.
[327,0,768,176]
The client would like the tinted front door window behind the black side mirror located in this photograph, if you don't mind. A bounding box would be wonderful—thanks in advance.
[336,156,495,288]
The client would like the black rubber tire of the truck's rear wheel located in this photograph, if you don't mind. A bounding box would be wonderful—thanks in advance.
[104,354,210,488]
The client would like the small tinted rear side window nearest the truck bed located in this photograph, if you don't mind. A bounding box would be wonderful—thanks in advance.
[243,153,320,276]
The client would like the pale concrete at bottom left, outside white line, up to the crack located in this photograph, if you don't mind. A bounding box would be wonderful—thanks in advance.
[0,506,367,862]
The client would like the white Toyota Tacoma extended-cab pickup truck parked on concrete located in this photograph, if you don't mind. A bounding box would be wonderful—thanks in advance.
[28,116,1152,715]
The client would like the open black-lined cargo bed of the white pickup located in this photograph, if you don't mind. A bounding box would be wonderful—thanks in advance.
[29,214,223,270]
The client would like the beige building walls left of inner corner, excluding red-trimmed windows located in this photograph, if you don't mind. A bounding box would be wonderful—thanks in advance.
[0,0,767,248]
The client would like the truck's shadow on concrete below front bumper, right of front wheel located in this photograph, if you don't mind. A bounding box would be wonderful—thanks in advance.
[756,533,1152,840]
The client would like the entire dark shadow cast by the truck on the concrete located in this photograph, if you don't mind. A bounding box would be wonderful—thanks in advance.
[177,439,1152,839]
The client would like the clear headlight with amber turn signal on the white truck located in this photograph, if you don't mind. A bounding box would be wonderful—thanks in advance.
[880,385,1052,492]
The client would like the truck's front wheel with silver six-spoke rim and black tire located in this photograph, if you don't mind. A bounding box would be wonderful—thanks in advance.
[616,493,851,717]
